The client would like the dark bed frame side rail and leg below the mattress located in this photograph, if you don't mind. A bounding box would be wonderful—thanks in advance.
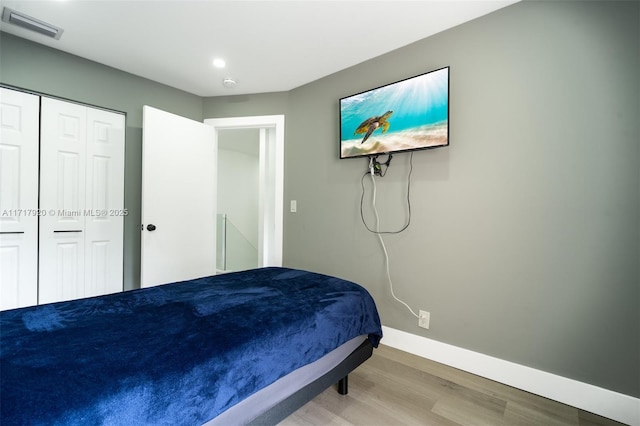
[248,339,373,426]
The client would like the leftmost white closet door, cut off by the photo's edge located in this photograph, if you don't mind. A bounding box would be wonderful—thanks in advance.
[0,88,40,310]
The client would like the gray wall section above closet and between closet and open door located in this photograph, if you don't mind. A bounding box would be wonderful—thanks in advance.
[0,32,203,289]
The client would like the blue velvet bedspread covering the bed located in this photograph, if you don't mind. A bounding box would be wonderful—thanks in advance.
[0,268,382,426]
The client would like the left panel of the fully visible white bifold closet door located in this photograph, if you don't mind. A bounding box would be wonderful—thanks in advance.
[39,98,87,303]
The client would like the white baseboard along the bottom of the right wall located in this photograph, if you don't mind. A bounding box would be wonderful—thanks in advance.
[381,326,640,426]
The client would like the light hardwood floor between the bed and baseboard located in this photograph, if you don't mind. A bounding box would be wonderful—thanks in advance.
[280,345,621,426]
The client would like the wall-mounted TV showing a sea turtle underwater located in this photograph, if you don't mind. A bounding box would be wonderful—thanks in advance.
[340,67,449,158]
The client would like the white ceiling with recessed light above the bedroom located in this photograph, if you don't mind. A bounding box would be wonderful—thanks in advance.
[0,0,518,96]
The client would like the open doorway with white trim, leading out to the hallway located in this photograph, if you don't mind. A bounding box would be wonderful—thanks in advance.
[204,115,284,272]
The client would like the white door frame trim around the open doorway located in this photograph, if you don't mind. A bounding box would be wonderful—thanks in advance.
[204,115,284,266]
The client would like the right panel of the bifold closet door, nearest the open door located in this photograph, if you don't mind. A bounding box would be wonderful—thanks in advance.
[85,108,126,296]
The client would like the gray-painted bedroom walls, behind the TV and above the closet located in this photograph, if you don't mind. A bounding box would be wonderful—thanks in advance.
[0,1,640,397]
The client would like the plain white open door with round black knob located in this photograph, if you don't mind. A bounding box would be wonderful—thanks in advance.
[141,106,217,287]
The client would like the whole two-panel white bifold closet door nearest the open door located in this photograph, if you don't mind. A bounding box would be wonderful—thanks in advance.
[39,98,126,303]
